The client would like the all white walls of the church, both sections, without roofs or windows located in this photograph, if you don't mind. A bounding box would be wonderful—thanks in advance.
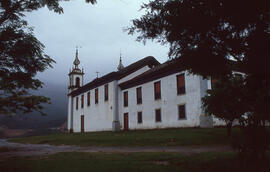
[68,66,228,132]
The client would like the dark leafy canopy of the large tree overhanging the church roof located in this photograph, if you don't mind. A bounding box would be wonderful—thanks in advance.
[128,0,270,76]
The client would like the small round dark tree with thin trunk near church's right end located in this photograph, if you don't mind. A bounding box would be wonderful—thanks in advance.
[202,75,245,136]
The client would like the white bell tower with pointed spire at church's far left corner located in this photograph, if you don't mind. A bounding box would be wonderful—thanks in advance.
[68,48,84,93]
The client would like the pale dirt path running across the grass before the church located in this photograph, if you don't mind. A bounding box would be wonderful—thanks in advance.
[0,139,233,160]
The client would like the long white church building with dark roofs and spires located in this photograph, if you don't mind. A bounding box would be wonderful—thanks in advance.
[67,50,220,132]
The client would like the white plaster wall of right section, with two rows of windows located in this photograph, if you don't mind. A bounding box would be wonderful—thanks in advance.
[119,70,201,129]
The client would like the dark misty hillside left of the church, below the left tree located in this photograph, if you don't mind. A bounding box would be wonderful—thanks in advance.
[0,83,67,130]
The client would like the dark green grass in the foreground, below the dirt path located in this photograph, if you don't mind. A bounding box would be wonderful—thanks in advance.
[0,152,270,172]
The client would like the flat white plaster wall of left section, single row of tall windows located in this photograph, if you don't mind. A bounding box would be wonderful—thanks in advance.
[73,82,114,132]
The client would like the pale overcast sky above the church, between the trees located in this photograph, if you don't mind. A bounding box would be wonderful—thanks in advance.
[26,0,168,85]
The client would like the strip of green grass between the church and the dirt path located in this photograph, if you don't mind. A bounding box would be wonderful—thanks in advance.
[9,128,239,146]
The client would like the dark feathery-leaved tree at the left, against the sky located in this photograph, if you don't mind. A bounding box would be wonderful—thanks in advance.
[0,0,96,114]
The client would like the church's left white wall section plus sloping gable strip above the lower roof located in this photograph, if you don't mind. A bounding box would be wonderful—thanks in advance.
[68,66,150,132]
